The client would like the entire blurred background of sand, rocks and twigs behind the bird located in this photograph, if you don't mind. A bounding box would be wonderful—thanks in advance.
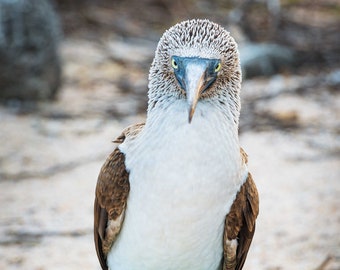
[0,0,340,270]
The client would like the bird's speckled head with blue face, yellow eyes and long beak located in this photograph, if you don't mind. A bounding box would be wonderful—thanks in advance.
[149,20,242,124]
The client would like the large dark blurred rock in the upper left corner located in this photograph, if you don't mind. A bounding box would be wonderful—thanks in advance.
[0,0,61,100]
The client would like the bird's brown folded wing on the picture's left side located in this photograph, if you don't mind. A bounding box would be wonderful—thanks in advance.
[94,124,144,270]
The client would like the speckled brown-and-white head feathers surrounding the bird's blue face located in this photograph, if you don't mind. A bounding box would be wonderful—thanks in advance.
[148,20,242,124]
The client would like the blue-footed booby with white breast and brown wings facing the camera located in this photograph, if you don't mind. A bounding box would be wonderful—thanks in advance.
[94,19,259,270]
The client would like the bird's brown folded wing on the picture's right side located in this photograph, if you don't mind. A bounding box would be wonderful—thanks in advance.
[223,149,259,270]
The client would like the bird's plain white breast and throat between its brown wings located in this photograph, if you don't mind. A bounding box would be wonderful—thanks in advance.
[108,101,243,270]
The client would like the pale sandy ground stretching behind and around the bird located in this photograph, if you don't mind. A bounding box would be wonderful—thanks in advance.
[0,37,340,270]
